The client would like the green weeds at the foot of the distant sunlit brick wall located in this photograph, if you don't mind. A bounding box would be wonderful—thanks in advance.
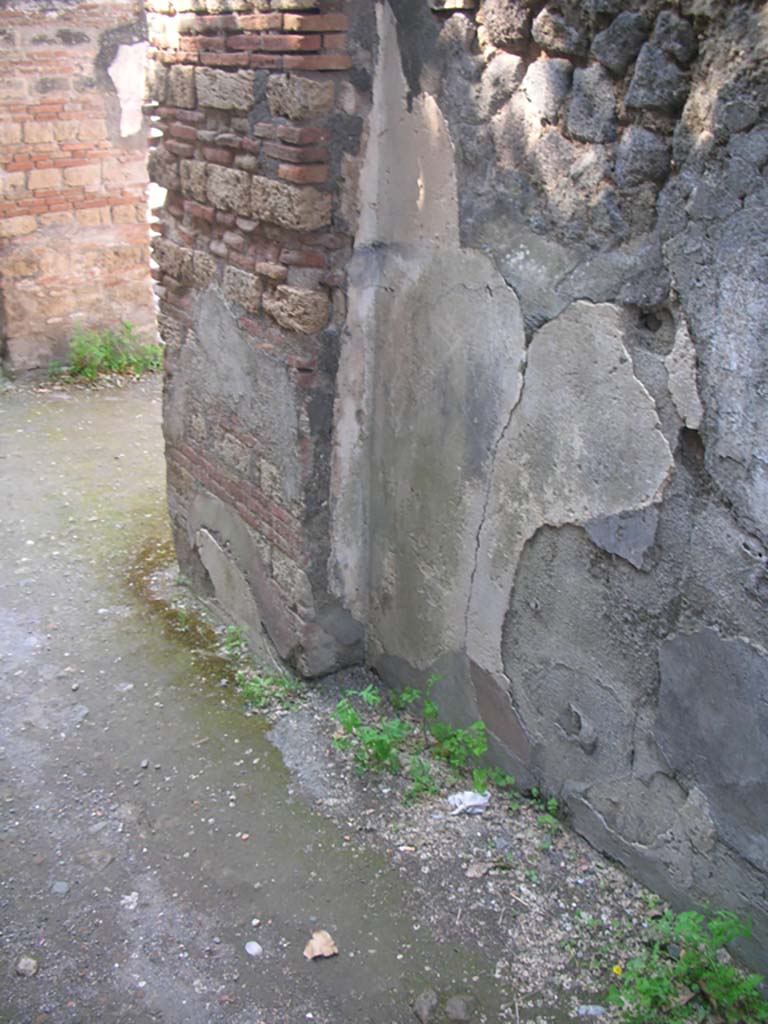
[58,324,163,381]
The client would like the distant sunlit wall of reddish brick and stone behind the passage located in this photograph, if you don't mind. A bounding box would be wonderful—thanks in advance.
[0,0,154,373]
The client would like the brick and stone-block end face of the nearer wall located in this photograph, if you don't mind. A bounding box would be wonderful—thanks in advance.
[147,0,370,675]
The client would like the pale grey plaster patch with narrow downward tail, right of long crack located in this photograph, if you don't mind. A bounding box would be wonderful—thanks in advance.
[467,302,673,676]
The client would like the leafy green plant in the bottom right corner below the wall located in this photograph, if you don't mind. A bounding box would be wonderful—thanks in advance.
[608,910,768,1024]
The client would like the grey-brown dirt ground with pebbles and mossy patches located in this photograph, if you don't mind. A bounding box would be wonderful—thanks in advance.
[0,380,656,1024]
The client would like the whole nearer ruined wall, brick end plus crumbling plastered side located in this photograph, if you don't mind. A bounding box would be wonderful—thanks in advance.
[151,0,768,968]
